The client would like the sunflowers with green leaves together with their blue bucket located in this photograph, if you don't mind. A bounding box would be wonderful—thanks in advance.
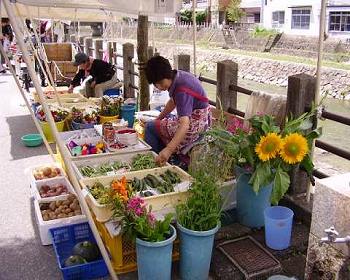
[208,109,321,227]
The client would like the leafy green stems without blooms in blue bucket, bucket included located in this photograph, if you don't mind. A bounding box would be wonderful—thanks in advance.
[176,172,221,279]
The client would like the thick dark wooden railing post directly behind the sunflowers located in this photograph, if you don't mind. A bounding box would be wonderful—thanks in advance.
[286,73,316,194]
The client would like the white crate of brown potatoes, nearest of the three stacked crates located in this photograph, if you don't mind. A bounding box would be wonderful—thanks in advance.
[34,194,86,245]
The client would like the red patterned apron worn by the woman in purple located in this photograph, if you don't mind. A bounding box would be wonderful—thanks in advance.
[155,87,211,153]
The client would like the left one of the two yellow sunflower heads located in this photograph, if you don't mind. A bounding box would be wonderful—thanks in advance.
[255,133,282,161]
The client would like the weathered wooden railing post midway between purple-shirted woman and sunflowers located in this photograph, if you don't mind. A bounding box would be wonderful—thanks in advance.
[216,60,238,112]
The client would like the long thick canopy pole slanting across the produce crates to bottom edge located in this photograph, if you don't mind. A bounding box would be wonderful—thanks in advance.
[3,0,118,280]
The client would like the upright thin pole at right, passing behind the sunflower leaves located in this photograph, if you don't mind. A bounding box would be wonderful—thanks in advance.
[306,0,327,202]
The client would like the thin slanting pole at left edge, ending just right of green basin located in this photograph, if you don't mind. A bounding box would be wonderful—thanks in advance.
[0,44,56,161]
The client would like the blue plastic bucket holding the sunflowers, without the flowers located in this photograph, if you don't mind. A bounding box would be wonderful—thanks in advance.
[235,167,272,228]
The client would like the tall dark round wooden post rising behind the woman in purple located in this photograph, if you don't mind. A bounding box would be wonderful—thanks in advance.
[137,15,150,111]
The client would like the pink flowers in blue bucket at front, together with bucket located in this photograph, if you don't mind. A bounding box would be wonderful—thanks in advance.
[114,197,176,280]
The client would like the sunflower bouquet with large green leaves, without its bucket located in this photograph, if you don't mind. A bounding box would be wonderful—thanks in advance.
[208,109,321,205]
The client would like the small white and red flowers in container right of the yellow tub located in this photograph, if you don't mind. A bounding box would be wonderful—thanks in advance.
[71,107,98,130]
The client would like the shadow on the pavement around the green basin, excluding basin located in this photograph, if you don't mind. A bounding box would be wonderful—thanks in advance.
[6,115,54,160]
